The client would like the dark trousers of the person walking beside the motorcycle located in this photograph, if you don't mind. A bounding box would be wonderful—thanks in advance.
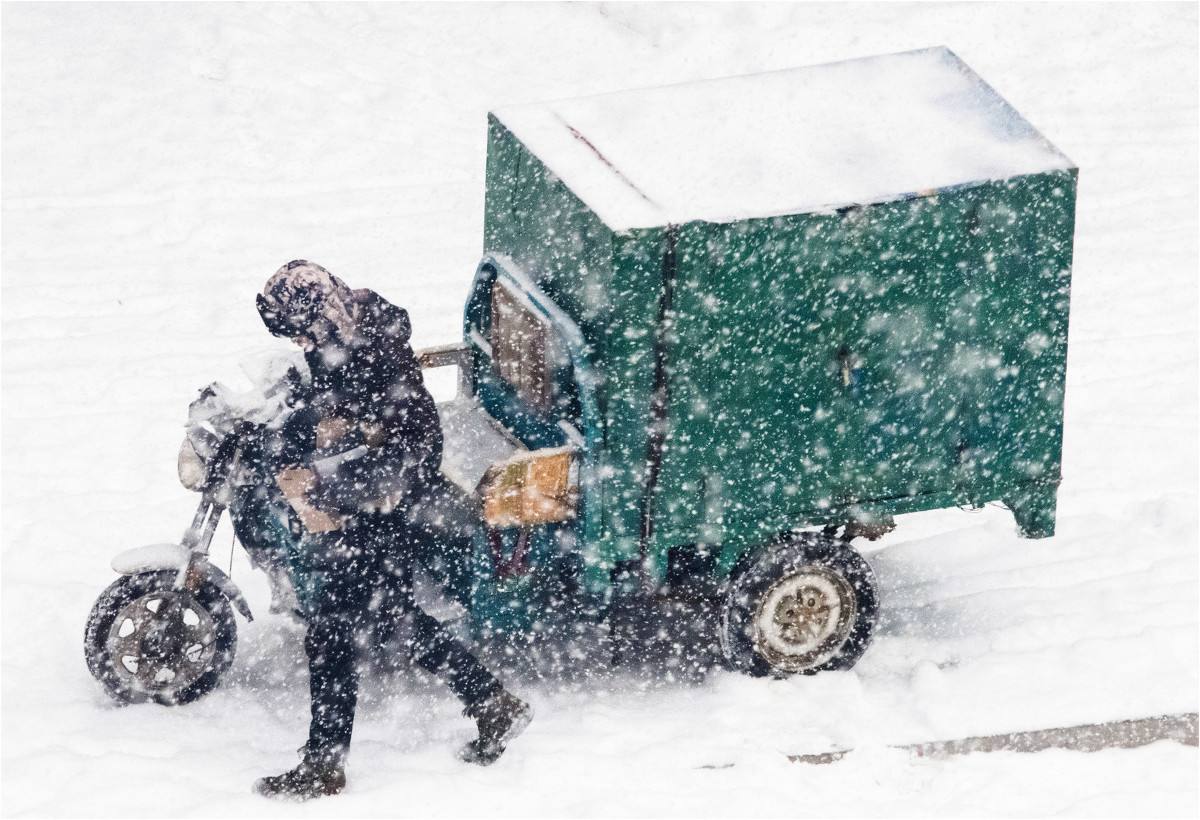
[305,515,500,764]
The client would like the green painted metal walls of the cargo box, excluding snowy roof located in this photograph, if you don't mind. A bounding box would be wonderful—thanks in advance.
[467,112,1076,600]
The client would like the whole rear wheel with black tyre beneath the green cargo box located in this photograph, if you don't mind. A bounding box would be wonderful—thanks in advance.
[720,533,877,677]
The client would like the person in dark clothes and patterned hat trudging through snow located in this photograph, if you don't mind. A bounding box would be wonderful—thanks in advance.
[254,259,533,800]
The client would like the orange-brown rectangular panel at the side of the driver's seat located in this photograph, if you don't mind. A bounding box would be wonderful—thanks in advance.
[480,448,580,527]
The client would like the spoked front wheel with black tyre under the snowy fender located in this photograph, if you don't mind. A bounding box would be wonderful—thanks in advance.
[84,570,238,706]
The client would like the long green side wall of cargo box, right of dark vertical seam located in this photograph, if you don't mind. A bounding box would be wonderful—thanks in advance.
[655,172,1074,565]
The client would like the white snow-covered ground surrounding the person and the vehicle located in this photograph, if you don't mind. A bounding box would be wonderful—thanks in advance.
[0,4,1200,816]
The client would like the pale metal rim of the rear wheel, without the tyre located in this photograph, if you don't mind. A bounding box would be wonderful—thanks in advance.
[754,565,854,672]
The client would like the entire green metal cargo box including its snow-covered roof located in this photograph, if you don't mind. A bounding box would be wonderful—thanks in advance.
[467,48,1078,580]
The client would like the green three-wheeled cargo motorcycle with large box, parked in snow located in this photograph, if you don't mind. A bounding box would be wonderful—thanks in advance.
[86,48,1076,702]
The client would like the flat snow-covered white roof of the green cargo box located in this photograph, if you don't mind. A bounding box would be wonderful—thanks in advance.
[494,48,1074,231]
